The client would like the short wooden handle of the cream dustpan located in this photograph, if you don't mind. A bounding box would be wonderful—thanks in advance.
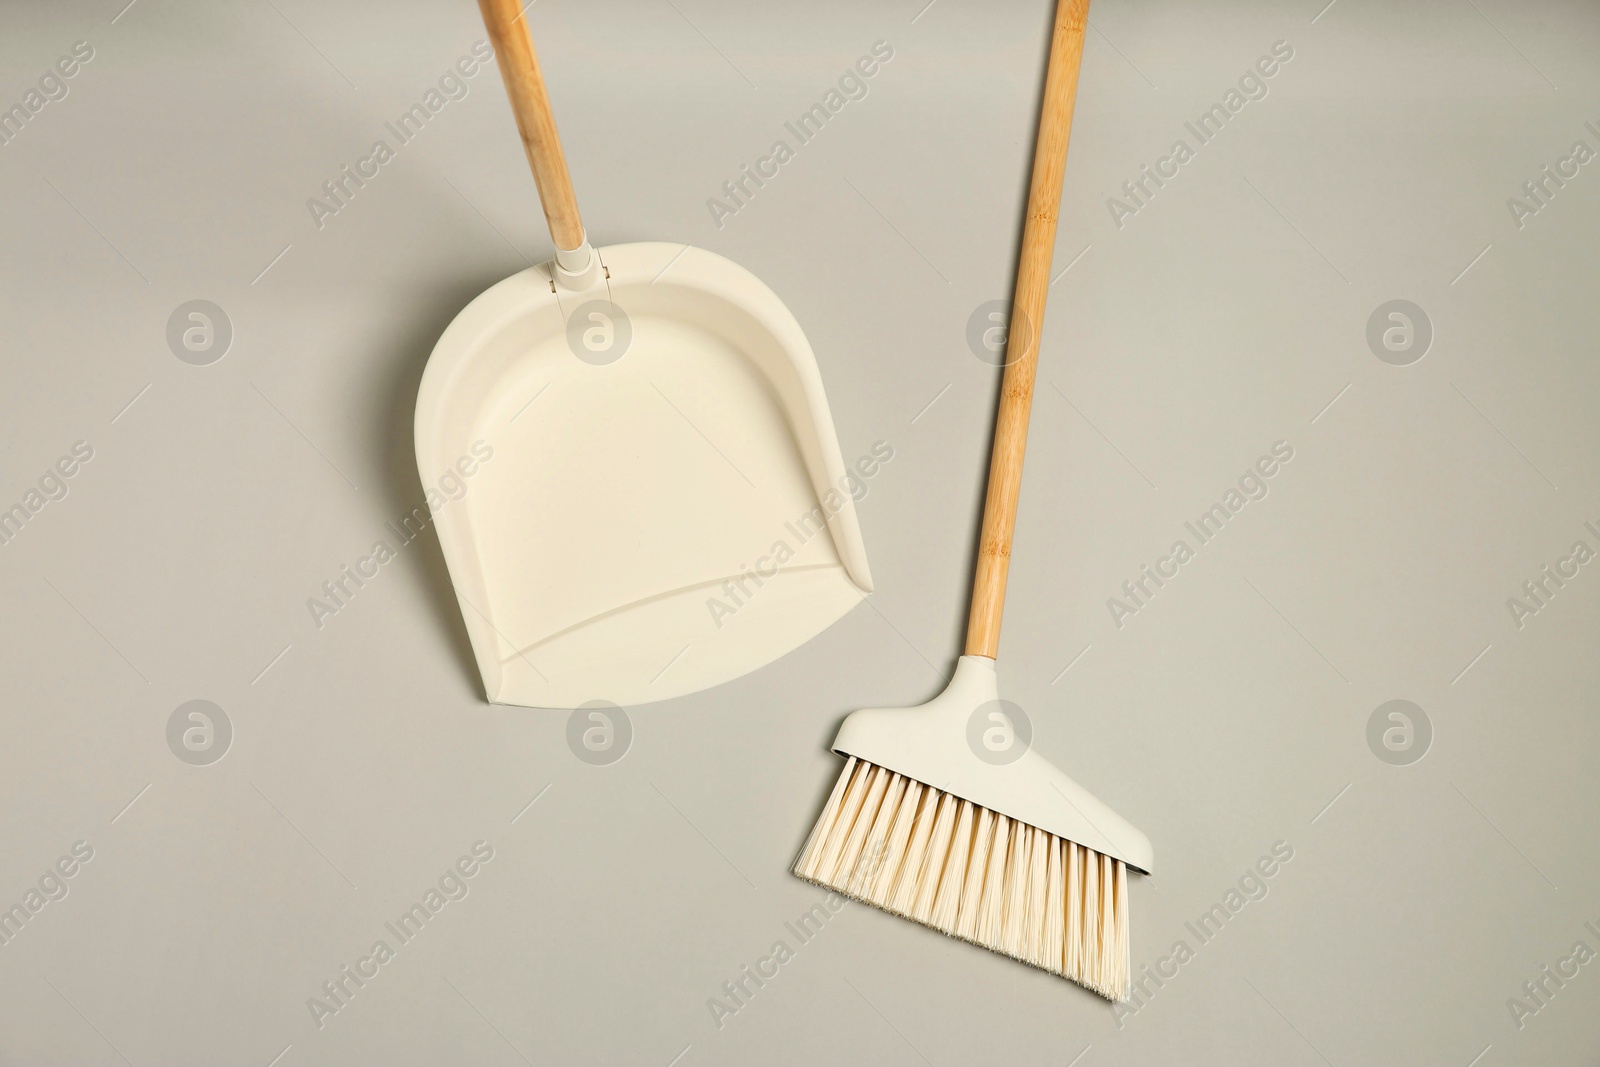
[478,0,584,251]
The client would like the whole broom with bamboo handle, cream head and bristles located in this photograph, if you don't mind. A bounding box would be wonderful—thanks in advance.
[794,0,1152,1000]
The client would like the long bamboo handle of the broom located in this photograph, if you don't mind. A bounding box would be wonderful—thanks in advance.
[960,0,1090,659]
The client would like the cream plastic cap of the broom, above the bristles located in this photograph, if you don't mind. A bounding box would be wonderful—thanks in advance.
[834,656,1155,873]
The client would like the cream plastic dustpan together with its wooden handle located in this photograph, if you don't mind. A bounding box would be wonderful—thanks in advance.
[406,0,885,709]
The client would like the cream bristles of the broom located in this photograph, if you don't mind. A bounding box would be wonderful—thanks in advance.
[794,757,1131,1000]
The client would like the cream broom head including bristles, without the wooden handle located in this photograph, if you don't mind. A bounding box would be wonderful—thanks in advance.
[794,656,1152,1000]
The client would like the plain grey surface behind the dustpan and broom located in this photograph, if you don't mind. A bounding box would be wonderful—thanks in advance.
[0,0,1600,1067]
